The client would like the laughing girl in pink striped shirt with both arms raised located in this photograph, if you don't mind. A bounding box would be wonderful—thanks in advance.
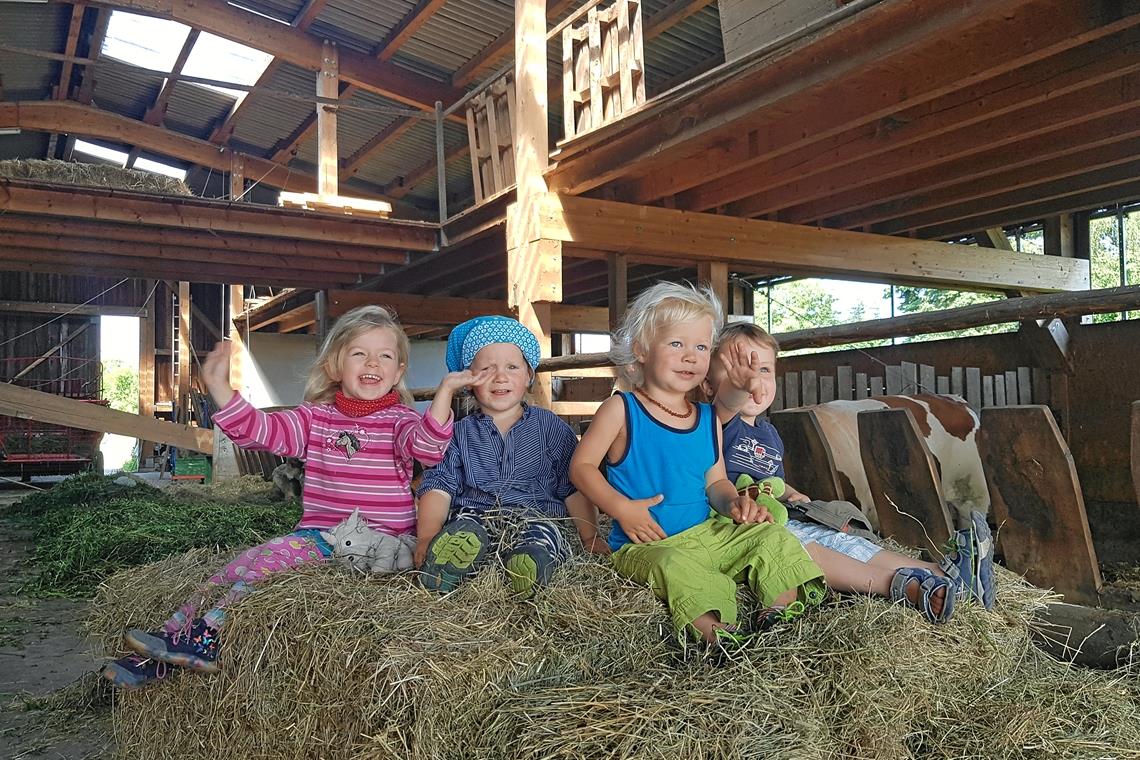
[104,307,491,688]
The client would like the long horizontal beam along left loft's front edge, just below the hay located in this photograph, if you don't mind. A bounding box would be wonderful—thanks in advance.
[0,178,437,251]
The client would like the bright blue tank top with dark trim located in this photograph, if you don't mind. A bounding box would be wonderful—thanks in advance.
[605,392,720,551]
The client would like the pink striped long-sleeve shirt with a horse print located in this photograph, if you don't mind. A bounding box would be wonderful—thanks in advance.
[213,393,451,536]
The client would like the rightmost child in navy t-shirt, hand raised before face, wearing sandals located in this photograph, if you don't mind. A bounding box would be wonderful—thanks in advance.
[705,322,994,622]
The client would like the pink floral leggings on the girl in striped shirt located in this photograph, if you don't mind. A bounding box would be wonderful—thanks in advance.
[163,528,333,634]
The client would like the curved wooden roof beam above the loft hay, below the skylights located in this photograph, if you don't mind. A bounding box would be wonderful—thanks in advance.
[0,101,317,193]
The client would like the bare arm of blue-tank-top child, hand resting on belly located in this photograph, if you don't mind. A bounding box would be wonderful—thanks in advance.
[570,395,666,544]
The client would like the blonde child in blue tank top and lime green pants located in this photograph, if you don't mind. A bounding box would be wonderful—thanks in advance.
[570,283,824,643]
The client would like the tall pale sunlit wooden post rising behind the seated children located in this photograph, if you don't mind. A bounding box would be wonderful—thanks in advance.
[507,0,562,408]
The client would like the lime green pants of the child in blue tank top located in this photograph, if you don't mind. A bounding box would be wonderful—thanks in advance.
[612,517,824,634]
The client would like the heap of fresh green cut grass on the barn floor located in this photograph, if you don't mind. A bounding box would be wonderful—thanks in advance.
[3,474,300,596]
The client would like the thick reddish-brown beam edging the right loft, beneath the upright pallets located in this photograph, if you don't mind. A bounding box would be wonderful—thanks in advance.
[551,0,1140,199]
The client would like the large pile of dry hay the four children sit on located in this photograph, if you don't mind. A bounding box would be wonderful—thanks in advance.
[90,551,1140,760]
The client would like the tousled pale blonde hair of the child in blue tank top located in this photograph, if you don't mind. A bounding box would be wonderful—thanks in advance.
[610,283,724,387]
